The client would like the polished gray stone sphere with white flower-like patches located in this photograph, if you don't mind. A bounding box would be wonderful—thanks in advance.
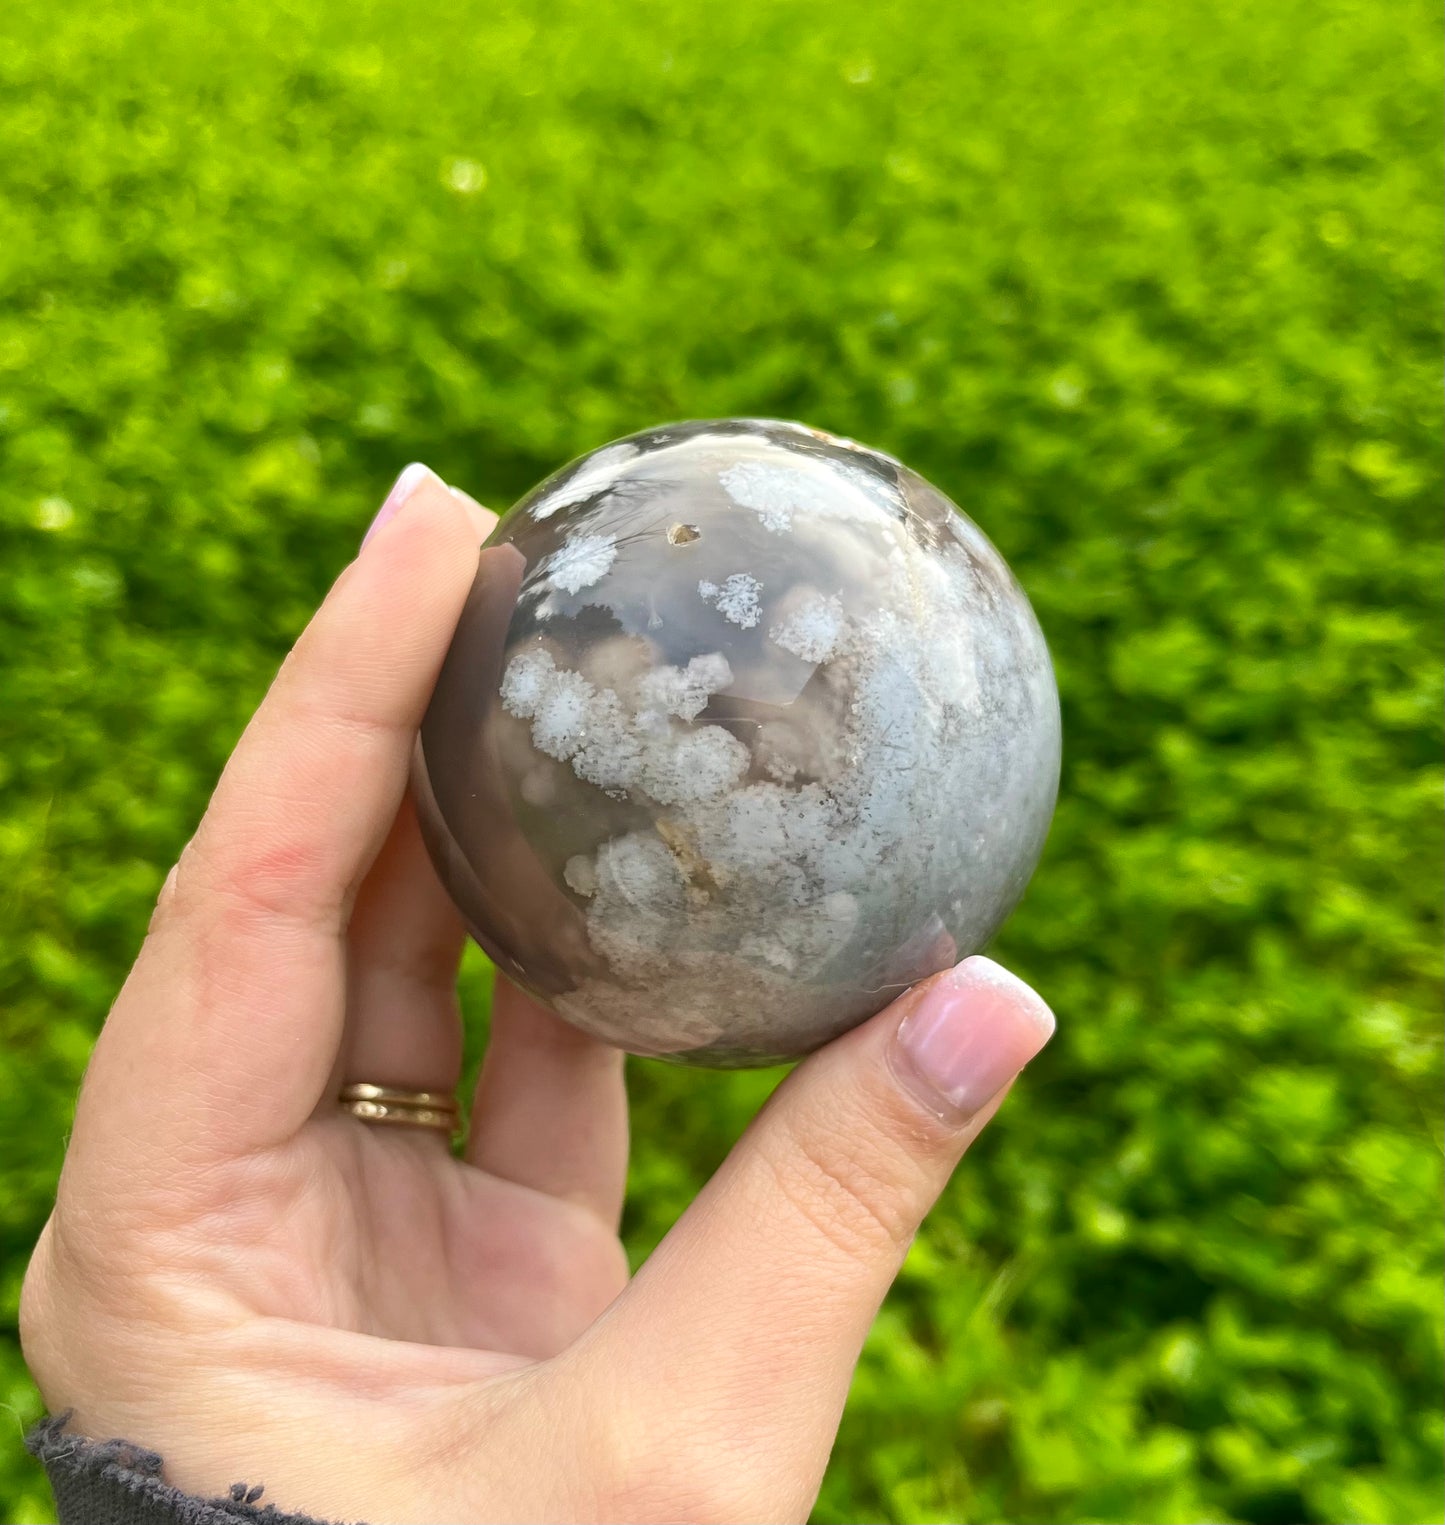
[413,419,1059,1066]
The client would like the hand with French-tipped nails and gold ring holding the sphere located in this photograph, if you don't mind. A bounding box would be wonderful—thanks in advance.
[21,471,1053,1522]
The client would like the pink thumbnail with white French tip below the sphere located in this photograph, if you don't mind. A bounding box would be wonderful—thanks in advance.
[889,956,1055,1122]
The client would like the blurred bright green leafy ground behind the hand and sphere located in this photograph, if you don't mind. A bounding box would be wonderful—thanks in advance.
[0,0,1442,1525]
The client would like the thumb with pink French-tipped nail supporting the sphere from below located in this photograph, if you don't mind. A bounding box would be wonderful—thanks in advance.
[570,958,1053,1519]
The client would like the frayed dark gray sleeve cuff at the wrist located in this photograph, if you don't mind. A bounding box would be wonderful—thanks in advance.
[26,1414,353,1525]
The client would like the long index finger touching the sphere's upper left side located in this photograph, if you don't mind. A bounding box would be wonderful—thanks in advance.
[76,468,480,1157]
